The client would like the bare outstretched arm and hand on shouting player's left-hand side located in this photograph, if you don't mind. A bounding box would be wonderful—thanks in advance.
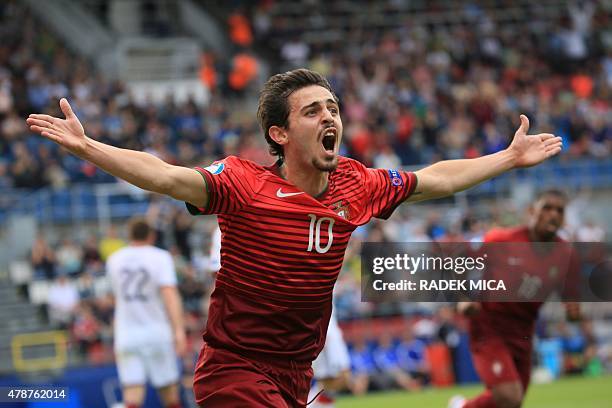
[26,98,208,207]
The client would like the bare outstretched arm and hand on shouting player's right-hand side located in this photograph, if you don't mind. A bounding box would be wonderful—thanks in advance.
[407,115,561,202]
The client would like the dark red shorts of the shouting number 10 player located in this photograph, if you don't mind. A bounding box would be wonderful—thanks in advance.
[193,343,313,408]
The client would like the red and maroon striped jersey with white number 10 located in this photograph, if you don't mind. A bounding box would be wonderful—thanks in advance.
[187,156,417,361]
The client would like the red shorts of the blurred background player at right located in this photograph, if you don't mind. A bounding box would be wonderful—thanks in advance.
[470,335,532,391]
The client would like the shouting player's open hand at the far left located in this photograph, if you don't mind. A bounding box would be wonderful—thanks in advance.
[26,98,87,156]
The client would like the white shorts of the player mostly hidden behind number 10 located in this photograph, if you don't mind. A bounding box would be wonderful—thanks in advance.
[312,314,351,380]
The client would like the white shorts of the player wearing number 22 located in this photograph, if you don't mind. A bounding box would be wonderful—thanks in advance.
[115,342,179,388]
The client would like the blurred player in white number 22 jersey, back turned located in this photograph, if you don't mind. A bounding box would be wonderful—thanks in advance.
[107,219,186,408]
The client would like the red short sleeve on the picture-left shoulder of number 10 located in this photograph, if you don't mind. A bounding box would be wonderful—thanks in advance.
[185,156,254,215]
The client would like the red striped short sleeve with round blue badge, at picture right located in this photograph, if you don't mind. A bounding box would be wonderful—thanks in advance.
[364,168,417,219]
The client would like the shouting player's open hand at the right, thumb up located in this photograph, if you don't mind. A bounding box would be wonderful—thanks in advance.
[508,115,561,167]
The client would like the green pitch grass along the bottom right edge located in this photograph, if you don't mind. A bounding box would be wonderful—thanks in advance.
[337,376,612,408]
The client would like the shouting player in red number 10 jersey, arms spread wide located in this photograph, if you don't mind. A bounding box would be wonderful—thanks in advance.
[27,69,561,407]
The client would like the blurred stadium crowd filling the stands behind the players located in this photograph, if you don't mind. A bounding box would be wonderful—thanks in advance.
[0,0,612,393]
